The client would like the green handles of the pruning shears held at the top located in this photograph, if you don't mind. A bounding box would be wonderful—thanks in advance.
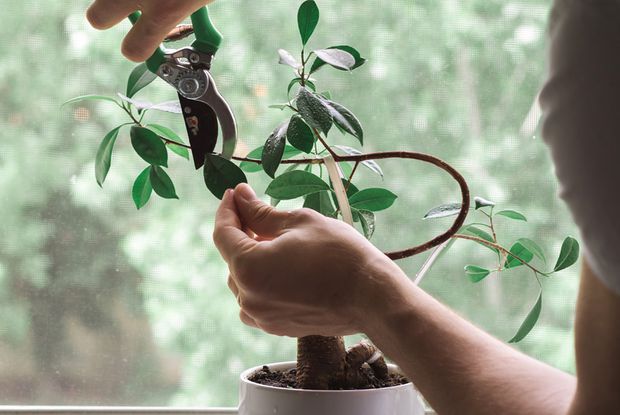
[129,6,222,73]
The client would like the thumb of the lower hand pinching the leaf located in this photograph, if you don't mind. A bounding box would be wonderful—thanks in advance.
[234,183,290,238]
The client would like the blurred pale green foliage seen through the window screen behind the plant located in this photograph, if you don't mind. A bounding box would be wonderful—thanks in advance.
[0,0,578,406]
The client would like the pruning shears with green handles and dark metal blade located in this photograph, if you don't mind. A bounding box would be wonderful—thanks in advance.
[129,6,237,169]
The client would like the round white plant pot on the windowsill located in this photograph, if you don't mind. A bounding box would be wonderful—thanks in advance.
[239,362,424,415]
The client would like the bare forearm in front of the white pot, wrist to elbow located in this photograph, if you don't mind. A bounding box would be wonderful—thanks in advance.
[366,270,576,415]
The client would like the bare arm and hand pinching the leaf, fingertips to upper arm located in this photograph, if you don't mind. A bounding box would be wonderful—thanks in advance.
[214,184,620,415]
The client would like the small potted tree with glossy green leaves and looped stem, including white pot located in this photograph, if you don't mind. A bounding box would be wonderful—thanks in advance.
[69,0,579,415]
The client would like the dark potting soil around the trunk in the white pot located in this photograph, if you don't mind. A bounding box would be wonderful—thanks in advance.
[248,365,409,390]
